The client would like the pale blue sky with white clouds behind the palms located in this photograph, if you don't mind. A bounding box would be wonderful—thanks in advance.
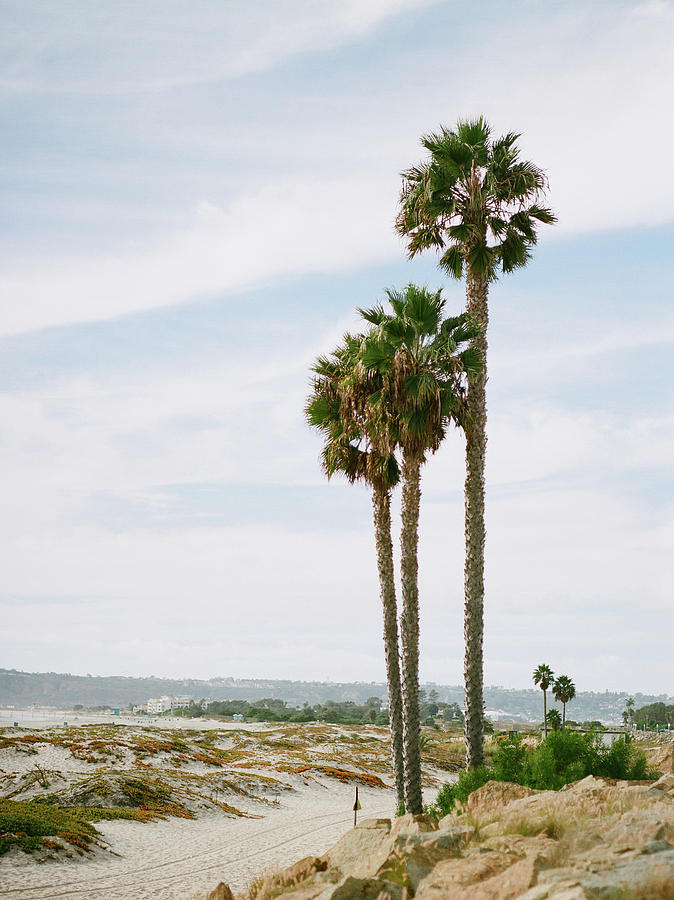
[0,0,674,694]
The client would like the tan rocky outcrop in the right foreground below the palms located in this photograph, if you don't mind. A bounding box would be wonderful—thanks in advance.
[205,774,674,900]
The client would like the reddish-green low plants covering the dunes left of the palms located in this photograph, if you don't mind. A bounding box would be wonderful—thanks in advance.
[0,722,410,857]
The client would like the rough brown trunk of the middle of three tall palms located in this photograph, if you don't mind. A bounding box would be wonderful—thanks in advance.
[400,453,423,815]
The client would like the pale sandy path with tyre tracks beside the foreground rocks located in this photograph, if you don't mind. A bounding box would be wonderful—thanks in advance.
[0,784,394,900]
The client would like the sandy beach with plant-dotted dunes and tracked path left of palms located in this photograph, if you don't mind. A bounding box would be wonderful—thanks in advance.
[0,720,449,900]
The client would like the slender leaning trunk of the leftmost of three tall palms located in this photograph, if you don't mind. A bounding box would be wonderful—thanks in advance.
[372,485,405,805]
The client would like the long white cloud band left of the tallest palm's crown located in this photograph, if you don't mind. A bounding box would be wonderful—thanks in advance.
[0,179,396,335]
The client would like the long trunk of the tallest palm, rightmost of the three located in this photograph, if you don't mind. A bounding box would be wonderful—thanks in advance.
[463,269,488,769]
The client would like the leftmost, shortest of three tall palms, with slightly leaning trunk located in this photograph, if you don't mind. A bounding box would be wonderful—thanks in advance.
[305,334,405,806]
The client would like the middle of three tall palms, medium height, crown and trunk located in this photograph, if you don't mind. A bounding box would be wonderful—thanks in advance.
[361,284,480,814]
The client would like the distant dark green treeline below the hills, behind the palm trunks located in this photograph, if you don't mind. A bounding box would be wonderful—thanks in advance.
[173,697,463,726]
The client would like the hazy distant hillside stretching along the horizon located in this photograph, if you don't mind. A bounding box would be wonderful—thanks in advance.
[0,669,674,722]
